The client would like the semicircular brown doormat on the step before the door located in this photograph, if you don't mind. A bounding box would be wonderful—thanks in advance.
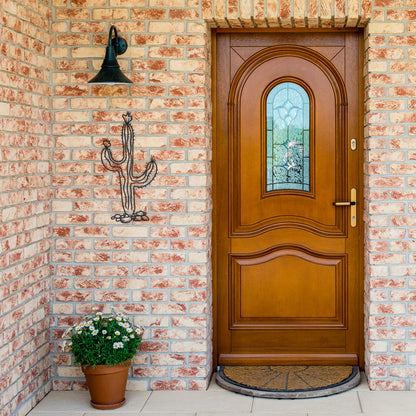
[216,365,360,399]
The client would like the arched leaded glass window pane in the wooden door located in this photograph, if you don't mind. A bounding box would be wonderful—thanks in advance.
[266,82,310,191]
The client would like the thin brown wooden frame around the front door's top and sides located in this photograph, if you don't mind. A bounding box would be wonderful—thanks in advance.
[211,28,365,371]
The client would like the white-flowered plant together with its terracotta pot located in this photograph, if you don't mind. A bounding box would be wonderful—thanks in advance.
[63,310,143,409]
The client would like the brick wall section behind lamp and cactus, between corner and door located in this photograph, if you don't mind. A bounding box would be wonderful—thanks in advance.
[52,0,212,390]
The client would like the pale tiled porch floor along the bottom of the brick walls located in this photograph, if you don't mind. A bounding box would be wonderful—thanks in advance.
[28,376,416,416]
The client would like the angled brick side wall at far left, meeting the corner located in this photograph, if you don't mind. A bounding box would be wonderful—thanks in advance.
[0,0,52,416]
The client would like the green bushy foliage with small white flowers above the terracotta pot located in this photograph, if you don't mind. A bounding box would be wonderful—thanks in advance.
[62,310,143,367]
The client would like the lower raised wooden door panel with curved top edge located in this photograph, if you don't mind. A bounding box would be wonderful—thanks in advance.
[231,250,343,327]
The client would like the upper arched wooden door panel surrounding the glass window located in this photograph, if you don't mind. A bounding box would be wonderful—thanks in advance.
[234,46,345,234]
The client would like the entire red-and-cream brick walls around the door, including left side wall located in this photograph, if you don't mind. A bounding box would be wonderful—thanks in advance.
[4,0,416,414]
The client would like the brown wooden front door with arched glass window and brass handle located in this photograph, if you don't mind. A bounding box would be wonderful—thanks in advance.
[214,32,363,365]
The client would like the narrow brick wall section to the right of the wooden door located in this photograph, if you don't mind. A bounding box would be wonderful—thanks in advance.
[365,0,416,390]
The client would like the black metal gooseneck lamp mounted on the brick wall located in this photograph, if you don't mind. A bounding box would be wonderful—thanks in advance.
[88,26,132,85]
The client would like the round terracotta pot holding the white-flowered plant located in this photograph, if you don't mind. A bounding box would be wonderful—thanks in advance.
[82,361,130,410]
